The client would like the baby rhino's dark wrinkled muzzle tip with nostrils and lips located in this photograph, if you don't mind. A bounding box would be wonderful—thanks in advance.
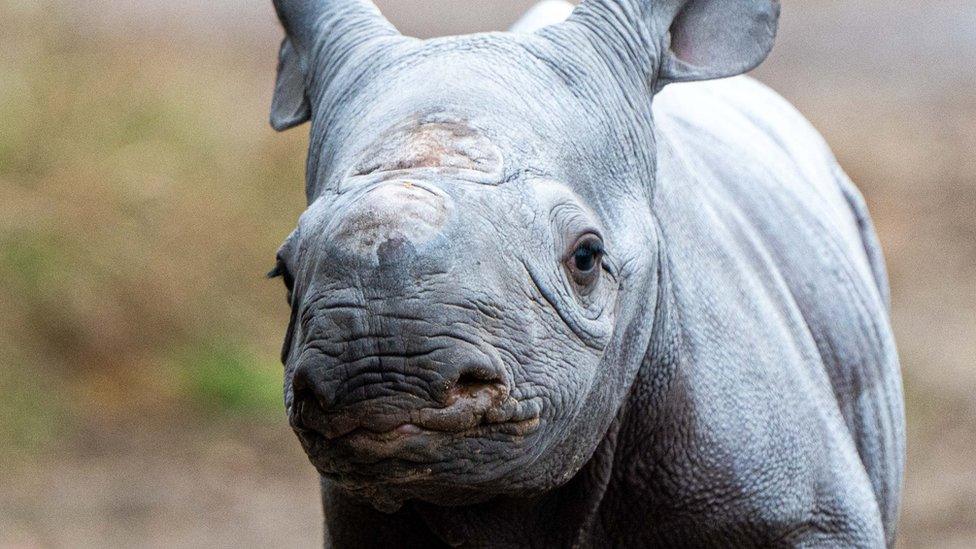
[291,349,523,441]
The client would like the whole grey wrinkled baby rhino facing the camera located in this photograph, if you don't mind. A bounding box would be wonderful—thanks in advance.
[272,0,904,547]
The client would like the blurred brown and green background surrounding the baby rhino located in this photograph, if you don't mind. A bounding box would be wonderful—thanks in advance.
[0,0,976,548]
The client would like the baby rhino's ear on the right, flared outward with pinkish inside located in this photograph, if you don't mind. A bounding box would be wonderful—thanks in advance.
[658,0,780,89]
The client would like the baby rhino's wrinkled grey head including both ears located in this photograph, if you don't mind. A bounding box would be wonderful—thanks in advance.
[271,0,778,510]
